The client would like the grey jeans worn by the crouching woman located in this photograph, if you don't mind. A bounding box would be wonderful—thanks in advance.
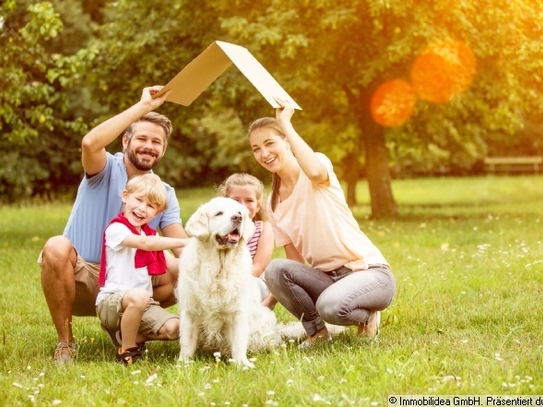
[265,259,396,336]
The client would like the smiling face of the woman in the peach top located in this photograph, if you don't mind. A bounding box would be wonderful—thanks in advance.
[249,128,288,172]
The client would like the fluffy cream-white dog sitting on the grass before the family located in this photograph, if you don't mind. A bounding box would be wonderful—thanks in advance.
[176,197,281,368]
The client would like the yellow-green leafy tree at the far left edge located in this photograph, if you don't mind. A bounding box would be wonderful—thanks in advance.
[0,1,98,201]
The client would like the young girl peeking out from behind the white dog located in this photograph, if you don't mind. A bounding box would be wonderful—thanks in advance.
[218,173,277,309]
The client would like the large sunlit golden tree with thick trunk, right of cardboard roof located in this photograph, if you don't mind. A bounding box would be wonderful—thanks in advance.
[218,0,543,217]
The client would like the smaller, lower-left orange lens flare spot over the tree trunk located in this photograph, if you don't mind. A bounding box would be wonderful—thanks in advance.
[370,79,417,127]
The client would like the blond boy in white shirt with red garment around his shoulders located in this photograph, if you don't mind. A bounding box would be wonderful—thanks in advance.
[96,173,187,365]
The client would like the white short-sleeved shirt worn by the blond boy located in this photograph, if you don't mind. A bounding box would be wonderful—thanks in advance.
[96,222,153,305]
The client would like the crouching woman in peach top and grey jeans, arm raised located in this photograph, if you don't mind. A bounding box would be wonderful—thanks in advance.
[248,100,396,348]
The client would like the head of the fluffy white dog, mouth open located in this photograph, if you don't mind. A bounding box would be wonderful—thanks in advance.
[185,197,255,249]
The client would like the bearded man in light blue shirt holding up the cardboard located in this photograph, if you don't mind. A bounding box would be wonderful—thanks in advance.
[38,86,187,363]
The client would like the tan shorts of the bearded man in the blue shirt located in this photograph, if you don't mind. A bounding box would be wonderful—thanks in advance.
[38,247,165,317]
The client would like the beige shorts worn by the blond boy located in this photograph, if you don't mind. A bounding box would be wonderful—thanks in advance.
[96,291,179,336]
